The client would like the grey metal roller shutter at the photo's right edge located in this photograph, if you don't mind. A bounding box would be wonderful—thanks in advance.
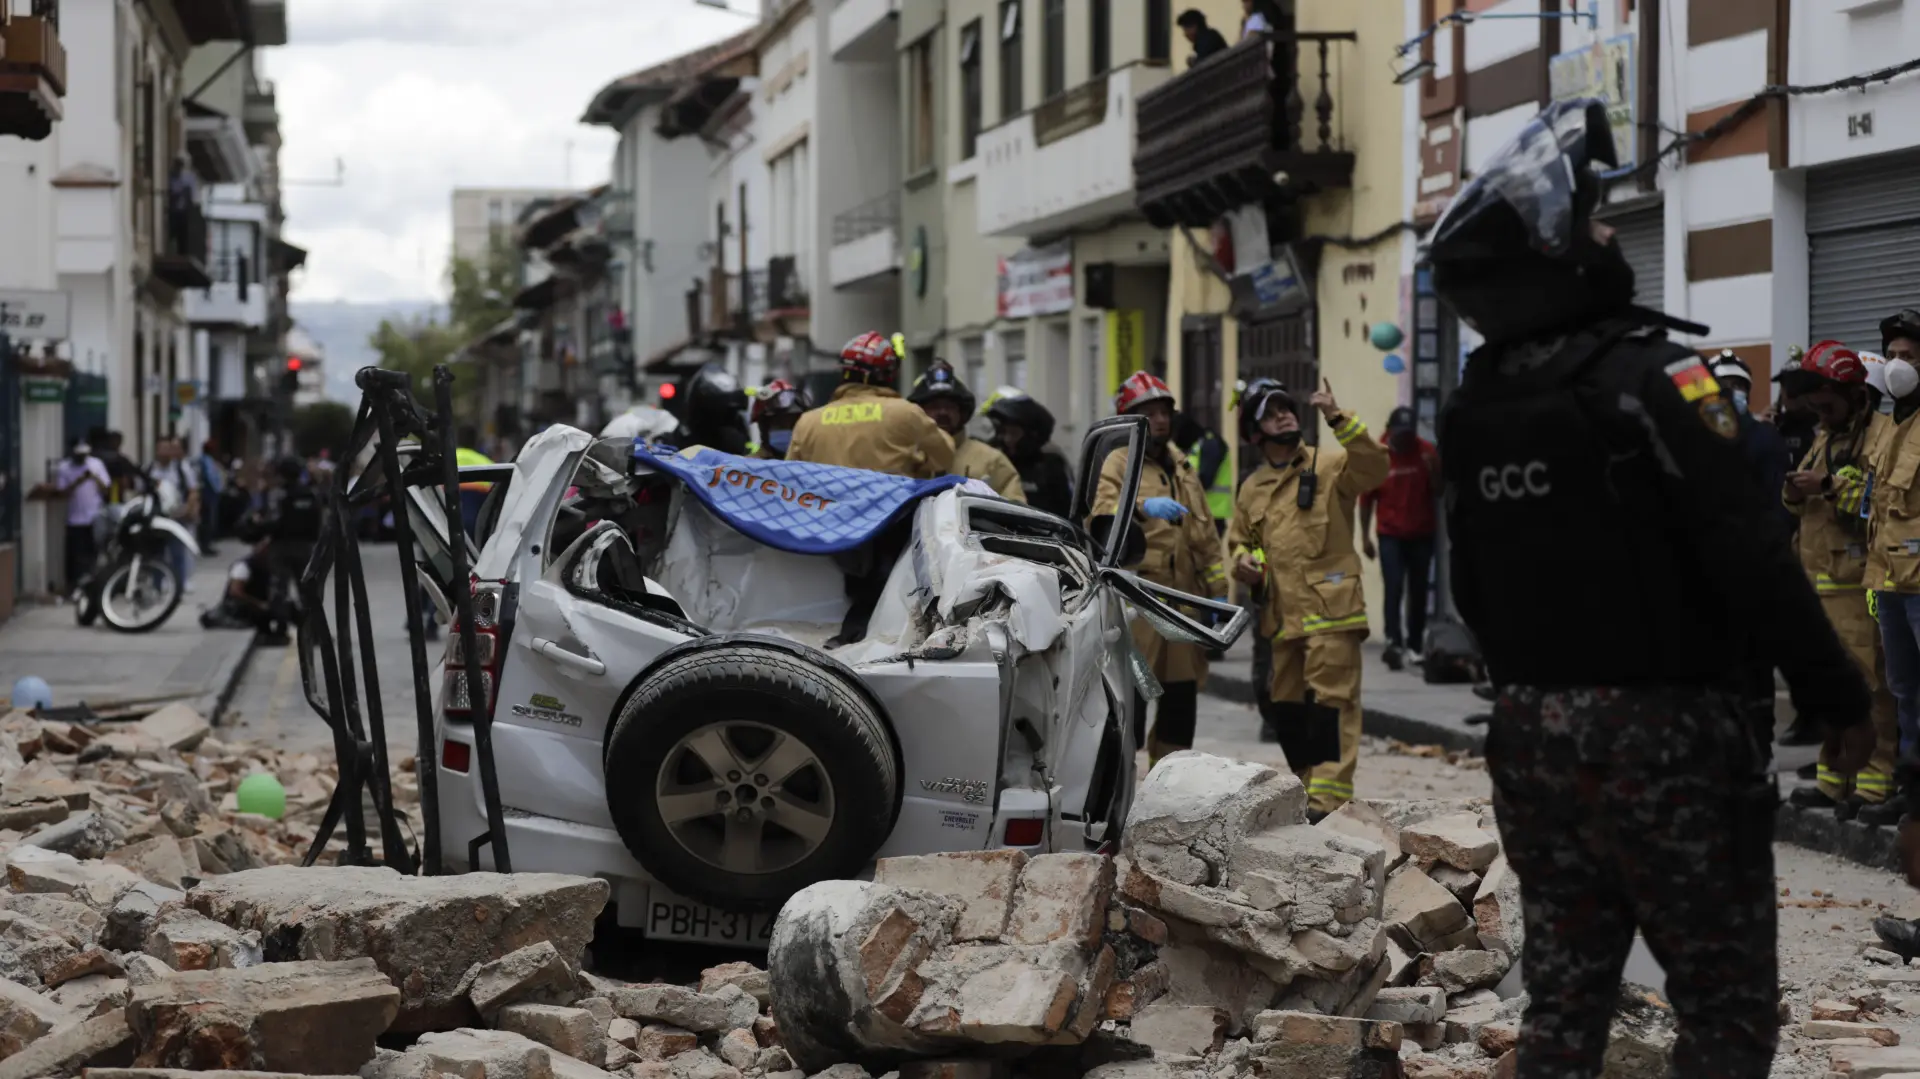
[1807,154,1920,349]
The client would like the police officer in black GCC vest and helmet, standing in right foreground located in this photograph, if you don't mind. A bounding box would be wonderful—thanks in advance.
[1427,100,1874,1079]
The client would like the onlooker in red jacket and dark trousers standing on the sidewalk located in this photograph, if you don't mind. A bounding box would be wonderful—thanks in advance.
[1359,405,1440,670]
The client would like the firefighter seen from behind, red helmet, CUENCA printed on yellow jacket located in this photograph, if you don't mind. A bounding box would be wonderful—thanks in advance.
[787,332,954,480]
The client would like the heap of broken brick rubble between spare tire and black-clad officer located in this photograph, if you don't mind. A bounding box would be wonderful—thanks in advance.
[768,753,1672,1079]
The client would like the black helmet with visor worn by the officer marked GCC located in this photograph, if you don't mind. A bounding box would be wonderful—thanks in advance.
[1425,98,1634,344]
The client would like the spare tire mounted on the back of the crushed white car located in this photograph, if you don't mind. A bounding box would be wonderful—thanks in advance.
[605,639,900,912]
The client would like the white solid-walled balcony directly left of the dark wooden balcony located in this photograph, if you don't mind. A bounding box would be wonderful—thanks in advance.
[975,61,1171,236]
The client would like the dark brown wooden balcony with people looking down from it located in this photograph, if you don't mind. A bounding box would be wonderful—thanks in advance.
[1133,31,1373,228]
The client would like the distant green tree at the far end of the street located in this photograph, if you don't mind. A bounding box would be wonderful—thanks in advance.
[369,236,520,422]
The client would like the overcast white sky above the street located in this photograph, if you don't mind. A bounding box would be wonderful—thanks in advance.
[263,0,758,301]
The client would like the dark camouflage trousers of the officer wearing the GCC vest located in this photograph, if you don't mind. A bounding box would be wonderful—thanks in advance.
[1486,685,1778,1079]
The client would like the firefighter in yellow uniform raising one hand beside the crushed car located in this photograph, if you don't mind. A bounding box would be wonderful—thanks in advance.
[1229,382,1388,820]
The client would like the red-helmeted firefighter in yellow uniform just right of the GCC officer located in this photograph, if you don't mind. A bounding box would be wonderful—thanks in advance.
[1778,342,1905,826]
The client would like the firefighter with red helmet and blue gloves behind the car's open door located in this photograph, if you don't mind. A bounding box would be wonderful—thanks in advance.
[1092,371,1227,764]
